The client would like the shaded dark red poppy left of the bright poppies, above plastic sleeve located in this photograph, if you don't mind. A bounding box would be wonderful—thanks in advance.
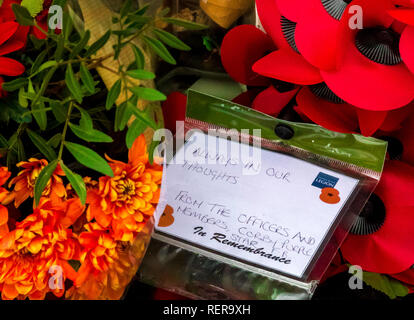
[221,25,298,116]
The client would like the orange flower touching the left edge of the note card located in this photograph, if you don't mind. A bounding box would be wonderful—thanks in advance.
[87,135,162,242]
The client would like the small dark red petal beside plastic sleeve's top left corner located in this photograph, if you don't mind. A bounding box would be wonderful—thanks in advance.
[162,92,187,133]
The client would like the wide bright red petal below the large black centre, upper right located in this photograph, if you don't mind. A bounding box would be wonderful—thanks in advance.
[321,45,414,111]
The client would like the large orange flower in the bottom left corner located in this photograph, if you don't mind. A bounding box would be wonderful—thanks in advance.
[0,198,84,299]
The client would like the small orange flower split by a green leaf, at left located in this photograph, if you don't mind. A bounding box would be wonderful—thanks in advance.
[9,158,66,208]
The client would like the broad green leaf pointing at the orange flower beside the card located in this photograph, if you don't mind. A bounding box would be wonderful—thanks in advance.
[65,142,114,177]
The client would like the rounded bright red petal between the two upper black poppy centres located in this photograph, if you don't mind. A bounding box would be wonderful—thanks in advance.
[295,1,340,70]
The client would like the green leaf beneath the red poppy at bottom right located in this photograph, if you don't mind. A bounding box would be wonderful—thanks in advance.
[363,272,409,299]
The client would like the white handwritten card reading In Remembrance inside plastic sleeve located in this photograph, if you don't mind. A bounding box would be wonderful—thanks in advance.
[157,132,358,278]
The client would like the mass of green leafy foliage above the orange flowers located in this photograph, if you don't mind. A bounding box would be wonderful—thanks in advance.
[0,0,206,203]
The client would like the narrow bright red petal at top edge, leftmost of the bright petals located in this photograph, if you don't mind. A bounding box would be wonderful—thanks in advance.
[256,0,294,52]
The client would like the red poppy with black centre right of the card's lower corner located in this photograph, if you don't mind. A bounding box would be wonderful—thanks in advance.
[341,161,414,274]
